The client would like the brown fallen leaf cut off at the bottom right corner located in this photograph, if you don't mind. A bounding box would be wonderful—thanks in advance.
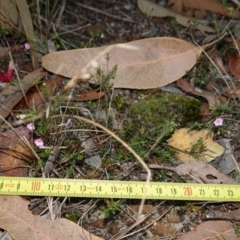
[177,221,240,240]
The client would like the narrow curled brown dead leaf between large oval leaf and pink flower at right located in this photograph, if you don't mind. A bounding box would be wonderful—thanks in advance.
[177,78,226,106]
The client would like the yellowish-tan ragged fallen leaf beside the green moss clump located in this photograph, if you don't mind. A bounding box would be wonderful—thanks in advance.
[168,128,225,163]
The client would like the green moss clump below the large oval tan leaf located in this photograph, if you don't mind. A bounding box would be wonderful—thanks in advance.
[127,92,201,137]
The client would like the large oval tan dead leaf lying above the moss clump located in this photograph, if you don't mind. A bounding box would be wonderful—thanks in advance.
[42,37,202,89]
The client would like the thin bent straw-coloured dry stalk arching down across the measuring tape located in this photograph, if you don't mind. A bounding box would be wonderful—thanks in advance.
[52,114,151,221]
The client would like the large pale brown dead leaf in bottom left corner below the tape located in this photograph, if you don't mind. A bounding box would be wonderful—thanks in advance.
[0,196,102,240]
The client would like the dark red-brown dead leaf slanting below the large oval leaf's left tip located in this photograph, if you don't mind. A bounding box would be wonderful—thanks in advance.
[13,76,62,111]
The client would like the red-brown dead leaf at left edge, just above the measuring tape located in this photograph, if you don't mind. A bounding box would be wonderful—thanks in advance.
[0,127,34,177]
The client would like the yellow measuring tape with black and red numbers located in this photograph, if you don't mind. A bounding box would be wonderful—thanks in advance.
[0,177,240,202]
